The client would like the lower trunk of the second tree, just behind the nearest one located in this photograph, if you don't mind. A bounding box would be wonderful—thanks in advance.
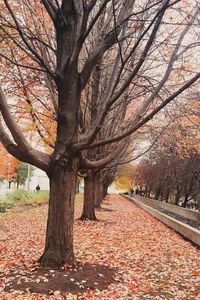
[80,170,97,221]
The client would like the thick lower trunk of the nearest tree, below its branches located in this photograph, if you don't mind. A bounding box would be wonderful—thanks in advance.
[39,160,78,268]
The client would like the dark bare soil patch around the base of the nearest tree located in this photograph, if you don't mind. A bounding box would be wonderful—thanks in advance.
[5,264,117,295]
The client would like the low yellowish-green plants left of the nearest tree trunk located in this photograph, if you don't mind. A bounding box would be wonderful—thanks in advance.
[0,190,49,213]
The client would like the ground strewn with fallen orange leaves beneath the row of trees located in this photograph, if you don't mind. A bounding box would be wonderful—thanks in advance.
[0,195,200,300]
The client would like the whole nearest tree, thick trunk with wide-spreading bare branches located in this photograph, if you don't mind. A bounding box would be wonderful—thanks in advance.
[0,0,200,267]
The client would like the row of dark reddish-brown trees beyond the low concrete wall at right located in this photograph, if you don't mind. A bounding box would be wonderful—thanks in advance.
[133,126,200,207]
